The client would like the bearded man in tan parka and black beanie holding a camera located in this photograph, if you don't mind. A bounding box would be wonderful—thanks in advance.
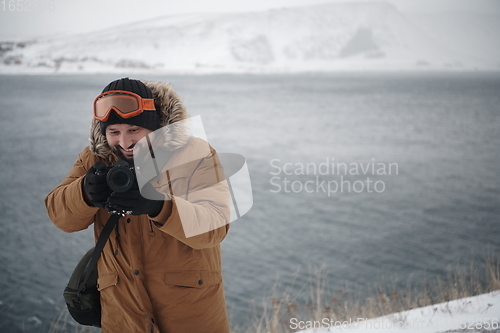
[45,78,230,333]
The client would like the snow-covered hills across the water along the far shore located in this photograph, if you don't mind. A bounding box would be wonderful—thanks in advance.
[0,2,500,73]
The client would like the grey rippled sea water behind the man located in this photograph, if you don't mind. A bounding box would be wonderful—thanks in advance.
[0,73,500,333]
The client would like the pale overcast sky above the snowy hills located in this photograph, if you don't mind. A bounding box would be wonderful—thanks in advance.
[0,0,500,38]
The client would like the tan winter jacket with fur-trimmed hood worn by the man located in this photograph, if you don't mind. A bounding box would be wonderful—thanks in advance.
[45,81,230,333]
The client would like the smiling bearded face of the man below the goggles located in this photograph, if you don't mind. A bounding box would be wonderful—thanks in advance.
[106,124,151,161]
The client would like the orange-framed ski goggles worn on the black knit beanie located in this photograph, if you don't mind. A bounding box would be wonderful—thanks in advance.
[94,90,156,121]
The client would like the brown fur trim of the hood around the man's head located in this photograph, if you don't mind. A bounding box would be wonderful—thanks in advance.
[89,81,190,162]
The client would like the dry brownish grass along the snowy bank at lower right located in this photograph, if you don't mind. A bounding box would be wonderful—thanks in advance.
[232,255,500,333]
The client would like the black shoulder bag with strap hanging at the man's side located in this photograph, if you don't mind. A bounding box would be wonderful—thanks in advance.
[63,214,120,327]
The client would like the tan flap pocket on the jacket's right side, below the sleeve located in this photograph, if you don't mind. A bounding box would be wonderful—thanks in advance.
[165,271,222,289]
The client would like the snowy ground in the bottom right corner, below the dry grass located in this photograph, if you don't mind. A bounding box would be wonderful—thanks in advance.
[291,291,500,333]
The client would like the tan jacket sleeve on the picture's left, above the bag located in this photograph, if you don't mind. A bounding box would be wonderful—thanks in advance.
[45,147,99,232]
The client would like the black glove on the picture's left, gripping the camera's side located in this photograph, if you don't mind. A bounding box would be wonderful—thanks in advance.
[83,161,112,208]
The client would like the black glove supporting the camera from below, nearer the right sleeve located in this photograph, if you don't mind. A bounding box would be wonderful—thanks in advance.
[107,184,164,216]
